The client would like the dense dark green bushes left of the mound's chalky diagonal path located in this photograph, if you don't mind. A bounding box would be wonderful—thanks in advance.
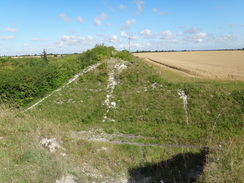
[0,45,115,107]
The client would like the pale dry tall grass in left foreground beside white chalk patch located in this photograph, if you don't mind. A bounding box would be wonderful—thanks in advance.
[0,105,66,183]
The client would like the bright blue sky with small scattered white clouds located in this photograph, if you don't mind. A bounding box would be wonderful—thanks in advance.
[0,0,244,56]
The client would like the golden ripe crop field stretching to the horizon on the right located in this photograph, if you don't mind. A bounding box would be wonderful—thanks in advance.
[134,51,244,80]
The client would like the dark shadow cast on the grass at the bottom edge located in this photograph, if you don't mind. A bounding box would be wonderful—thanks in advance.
[128,148,209,183]
